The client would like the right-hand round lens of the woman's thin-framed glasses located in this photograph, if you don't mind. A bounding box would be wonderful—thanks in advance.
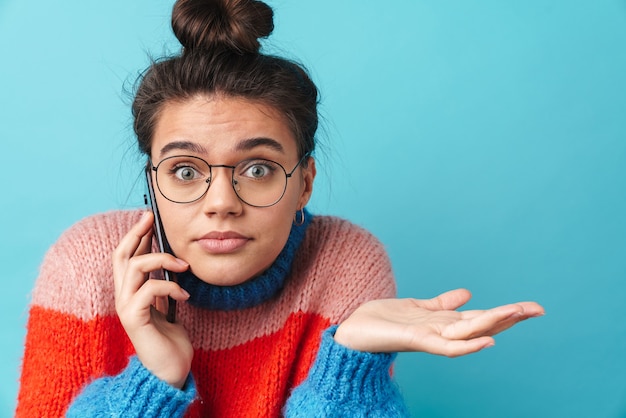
[233,159,287,206]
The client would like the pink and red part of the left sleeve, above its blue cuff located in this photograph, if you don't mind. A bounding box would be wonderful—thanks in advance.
[15,212,147,418]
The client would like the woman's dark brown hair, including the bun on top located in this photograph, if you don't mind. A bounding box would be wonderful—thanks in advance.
[132,0,318,157]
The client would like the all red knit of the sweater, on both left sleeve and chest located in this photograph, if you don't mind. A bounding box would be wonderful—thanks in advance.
[16,306,329,417]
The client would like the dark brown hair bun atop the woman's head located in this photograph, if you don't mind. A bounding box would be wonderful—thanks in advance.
[172,0,274,53]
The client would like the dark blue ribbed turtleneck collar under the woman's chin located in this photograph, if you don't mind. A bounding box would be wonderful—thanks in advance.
[177,209,312,311]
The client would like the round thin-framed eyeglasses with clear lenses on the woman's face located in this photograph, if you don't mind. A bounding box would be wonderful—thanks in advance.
[150,154,309,208]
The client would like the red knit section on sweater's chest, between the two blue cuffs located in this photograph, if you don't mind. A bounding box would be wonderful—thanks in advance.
[189,313,329,417]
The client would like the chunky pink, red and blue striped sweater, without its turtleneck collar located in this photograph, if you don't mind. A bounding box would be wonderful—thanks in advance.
[16,211,406,417]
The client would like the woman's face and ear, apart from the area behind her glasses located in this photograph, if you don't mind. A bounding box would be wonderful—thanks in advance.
[151,96,315,286]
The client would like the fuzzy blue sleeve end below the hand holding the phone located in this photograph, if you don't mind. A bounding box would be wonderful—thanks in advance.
[66,356,196,418]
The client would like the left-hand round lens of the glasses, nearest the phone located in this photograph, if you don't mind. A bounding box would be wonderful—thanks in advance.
[156,156,211,203]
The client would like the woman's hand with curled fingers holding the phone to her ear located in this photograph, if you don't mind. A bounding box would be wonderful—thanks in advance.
[113,212,193,388]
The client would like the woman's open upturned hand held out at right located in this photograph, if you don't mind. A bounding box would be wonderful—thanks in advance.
[335,289,544,357]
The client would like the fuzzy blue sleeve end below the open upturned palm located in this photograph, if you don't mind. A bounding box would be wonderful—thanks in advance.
[284,326,409,418]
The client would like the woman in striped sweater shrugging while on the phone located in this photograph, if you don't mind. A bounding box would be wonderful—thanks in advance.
[17,0,543,417]
